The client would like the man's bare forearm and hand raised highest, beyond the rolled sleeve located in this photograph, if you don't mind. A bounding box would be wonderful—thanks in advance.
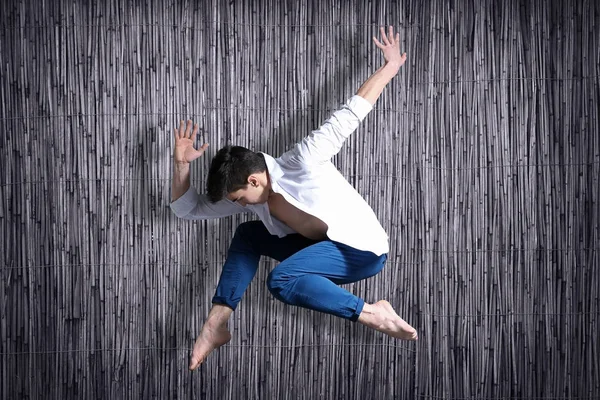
[356,26,406,105]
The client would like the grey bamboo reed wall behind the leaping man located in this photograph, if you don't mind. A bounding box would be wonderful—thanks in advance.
[0,0,600,399]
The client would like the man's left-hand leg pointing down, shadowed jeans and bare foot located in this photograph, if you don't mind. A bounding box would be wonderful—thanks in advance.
[190,221,316,369]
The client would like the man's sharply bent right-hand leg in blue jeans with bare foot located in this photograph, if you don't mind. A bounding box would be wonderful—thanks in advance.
[267,241,417,340]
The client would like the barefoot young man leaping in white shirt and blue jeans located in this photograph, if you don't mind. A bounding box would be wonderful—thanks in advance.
[171,26,417,370]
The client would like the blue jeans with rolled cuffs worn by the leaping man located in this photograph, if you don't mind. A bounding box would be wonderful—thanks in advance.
[212,221,387,321]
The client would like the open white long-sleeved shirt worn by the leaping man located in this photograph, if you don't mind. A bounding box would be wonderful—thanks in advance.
[171,96,389,255]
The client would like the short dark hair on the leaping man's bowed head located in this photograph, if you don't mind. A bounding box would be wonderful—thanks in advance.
[206,146,267,203]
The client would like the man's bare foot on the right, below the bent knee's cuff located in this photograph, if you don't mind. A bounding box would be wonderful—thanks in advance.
[358,300,418,340]
